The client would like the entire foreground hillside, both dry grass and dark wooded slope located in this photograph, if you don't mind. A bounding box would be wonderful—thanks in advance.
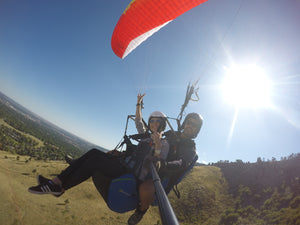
[0,151,300,225]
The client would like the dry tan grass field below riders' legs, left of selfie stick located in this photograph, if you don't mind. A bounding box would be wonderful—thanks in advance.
[0,151,160,225]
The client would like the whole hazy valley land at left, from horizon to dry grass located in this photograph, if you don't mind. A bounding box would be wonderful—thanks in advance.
[0,92,106,159]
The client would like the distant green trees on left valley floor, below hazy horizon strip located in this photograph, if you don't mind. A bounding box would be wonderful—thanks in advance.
[0,101,87,160]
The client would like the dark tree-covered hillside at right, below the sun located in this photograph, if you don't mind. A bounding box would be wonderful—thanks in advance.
[212,153,300,225]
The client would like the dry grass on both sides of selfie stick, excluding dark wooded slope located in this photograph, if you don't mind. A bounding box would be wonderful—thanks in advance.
[0,151,231,225]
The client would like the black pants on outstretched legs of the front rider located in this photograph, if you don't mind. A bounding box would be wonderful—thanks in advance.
[58,149,128,190]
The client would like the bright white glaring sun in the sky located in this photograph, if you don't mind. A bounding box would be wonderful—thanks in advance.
[221,65,271,108]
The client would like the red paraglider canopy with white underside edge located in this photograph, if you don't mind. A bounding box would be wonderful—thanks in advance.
[111,0,207,59]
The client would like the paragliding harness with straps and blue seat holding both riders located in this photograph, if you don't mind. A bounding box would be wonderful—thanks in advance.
[92,131,198,213]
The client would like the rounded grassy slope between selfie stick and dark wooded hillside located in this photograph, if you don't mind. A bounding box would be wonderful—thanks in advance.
[169,166,233,225]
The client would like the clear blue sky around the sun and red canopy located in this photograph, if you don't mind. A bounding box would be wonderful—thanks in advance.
[0,0,300,162]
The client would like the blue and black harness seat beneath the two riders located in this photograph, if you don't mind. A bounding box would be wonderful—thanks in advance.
[92,155,198,213]
